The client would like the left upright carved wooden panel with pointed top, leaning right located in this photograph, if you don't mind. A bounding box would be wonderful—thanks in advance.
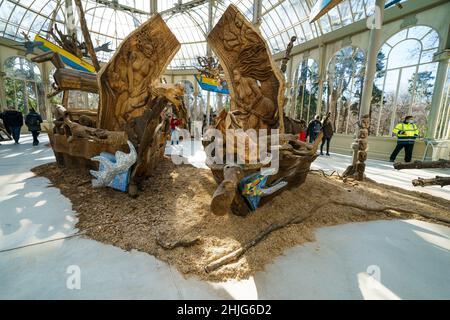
[97,15,181,130]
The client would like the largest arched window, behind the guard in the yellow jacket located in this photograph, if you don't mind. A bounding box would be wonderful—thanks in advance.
[372,26,439,135]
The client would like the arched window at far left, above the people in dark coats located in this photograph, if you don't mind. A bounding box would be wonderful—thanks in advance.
[4,57,47,119]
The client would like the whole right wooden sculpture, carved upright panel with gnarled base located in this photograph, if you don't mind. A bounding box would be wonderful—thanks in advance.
[205,5,321,215]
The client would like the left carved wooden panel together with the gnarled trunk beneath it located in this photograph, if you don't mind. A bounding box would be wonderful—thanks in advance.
[98,15,183,196]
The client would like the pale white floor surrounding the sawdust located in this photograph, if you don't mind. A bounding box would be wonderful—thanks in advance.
[0,136,450,299]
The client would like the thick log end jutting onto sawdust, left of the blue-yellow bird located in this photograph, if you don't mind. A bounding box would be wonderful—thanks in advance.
[211,166,244,216]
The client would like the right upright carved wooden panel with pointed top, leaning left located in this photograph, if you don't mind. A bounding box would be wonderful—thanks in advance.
[208,5,284,129]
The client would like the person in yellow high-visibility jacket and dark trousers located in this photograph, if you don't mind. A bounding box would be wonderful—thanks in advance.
[390,116,419,162]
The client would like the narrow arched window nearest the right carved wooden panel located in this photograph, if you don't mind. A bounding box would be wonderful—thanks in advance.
[293,59,319,122]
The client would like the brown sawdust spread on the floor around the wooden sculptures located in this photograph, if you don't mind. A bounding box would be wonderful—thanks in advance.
[33,159,450,281]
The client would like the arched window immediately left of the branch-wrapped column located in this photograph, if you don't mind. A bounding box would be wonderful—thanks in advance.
[326,46,365,134]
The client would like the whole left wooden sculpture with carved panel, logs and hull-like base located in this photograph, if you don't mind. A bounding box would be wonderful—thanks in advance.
[38,15,186,196]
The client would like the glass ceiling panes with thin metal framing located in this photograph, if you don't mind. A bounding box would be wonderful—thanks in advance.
[0,0,384,69]
